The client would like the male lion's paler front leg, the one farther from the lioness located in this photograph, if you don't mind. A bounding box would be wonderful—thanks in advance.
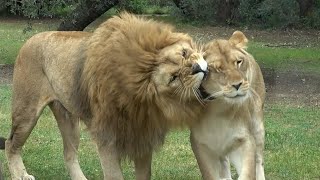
[97,139,123,180]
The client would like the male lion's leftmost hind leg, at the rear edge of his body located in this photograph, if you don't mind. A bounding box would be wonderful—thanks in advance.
[5,87,52,180]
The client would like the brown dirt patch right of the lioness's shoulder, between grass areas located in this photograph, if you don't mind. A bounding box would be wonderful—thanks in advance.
[261,68,320,107]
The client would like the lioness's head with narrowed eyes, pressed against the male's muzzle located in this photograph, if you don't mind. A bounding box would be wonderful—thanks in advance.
[201,31,253,102]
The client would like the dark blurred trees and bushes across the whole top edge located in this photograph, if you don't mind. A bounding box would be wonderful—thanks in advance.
[0,0,320,30]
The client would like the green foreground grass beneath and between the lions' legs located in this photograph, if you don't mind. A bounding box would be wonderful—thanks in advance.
[0,85,320,180]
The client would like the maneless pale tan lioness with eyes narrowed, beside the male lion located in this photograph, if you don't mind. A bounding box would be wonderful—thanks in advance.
[191,31,265,180]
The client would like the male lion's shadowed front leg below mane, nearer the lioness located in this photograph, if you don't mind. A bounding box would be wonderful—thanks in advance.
[134,153,152,180]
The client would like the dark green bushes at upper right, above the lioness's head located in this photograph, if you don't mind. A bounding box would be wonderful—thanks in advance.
[175,0,320,28]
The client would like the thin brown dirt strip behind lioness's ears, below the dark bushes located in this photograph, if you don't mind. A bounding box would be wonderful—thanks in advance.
[178,26,320,48]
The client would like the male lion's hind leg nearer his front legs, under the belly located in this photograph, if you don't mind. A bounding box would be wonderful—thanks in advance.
[50,101,86,180]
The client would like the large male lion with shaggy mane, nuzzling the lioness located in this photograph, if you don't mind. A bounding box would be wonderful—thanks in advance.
[5,13,207,180]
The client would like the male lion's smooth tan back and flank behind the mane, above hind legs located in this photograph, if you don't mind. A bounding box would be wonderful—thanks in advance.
[13,31,91,115]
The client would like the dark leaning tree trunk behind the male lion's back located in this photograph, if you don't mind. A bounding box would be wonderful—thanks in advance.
[58,0,119,31]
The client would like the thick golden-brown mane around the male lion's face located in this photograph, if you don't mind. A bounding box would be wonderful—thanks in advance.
[74,13,199,157]
